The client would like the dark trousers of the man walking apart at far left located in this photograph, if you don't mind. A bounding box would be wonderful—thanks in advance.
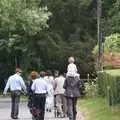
[11,90,20,118]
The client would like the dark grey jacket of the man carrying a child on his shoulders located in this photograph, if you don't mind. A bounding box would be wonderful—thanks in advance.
[64,77,81,97]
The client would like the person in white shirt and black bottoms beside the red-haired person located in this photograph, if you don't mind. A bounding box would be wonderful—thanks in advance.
[31,72,48,120]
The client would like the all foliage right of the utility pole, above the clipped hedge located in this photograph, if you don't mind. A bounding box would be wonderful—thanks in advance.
[93,0,120,68]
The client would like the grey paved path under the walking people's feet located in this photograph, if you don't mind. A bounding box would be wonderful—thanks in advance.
[0,98,84,120]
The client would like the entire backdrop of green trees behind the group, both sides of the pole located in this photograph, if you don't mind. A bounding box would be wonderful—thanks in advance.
[0,0,120,89]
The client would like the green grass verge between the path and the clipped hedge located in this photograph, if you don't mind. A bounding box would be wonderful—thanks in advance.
[79,98,120,120]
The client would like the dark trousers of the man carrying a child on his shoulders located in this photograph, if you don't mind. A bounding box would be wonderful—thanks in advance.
[67,97,77,120]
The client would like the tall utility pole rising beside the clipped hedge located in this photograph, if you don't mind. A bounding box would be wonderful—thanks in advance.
[97,0,103,71]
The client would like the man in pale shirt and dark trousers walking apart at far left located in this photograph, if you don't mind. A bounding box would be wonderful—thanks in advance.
[3,68,26,119]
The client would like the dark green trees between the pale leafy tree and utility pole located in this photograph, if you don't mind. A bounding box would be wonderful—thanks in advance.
[39,0,96,76]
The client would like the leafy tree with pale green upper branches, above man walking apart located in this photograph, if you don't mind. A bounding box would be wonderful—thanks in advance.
[0,0,51,89]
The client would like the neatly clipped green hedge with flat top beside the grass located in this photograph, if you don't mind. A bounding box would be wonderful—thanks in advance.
[98,69,120,105]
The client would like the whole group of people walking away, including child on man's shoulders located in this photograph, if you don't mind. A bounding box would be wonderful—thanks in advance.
[3,57,81,120]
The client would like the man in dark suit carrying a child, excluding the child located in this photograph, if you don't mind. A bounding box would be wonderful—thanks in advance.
[64,75,81,120]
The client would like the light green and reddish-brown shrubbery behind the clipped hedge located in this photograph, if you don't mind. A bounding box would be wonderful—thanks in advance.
[93,33,120,69]
